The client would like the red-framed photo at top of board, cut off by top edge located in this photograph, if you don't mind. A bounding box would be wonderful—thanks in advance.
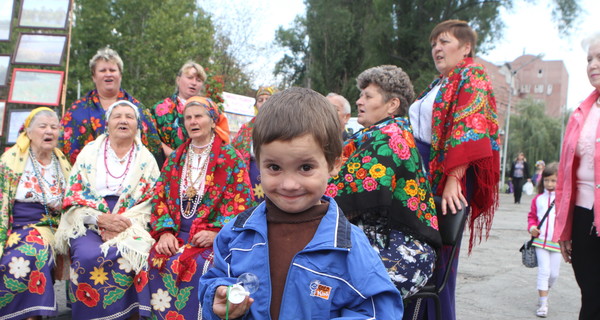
[18,0,70,29]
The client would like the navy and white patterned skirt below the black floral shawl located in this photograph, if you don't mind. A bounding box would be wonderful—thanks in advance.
[367,230,436,299]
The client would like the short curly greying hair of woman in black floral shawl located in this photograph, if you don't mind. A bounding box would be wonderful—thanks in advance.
[356,65,415,116]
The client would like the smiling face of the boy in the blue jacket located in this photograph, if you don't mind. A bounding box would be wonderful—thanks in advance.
[259,134,341,213]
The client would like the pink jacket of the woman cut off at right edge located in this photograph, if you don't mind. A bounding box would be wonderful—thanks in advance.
[552,90,600,242]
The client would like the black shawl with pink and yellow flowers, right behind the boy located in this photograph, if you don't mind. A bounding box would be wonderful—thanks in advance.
[325,118,441,248]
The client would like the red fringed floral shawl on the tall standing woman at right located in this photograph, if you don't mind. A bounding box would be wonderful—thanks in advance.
[418,58,500,250]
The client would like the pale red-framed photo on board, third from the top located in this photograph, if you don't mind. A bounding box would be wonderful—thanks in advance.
[8,68,65,106]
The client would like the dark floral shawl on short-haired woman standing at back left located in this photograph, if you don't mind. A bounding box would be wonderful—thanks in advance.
[58,89,162,163]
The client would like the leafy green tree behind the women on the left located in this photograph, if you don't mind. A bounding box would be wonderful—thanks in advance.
[67,0,214,106]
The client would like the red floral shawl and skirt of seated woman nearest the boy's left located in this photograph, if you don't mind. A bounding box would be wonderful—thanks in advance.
[149,135,251,320]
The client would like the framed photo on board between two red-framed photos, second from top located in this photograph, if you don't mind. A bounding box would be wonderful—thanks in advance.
[13,33,67,66]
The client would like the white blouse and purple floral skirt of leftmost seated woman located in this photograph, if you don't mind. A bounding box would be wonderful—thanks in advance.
[0,147,70,319]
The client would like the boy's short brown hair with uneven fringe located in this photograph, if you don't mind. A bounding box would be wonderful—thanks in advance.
[252,87,342,170]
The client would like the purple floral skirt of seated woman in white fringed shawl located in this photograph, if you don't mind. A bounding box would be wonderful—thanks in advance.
[68,230,150,320]
